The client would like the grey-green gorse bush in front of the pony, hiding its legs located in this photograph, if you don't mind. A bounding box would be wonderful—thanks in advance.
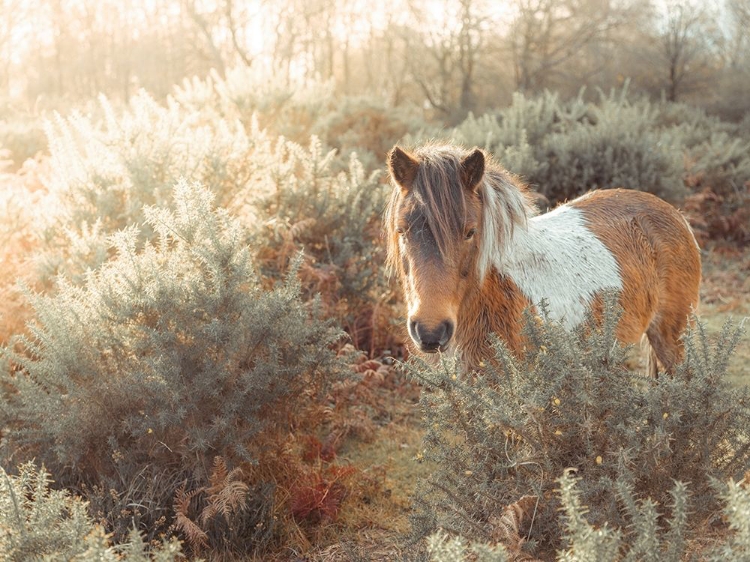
[406,299,750,558]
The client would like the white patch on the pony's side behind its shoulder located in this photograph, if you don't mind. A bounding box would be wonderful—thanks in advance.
[494,205,622,329]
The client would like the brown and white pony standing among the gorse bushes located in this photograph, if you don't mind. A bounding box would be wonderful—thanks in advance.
[384,143,701,376]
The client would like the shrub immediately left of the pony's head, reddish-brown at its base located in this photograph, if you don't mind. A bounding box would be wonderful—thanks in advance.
[251,137,390,350]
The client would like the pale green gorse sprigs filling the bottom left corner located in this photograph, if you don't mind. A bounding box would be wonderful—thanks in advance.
[0,463,180,562]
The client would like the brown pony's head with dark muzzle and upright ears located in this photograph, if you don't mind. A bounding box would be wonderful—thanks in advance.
[385,146,487,353]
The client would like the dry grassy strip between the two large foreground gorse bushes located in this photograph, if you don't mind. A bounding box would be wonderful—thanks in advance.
[290,362,431,562]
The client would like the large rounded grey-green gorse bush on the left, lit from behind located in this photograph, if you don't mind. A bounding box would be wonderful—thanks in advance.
[0,182,341,548]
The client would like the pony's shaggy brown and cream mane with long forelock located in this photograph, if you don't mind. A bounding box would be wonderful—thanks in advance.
[385,144,537,280]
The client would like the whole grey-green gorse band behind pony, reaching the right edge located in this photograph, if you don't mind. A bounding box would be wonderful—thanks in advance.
[451,88,750,207]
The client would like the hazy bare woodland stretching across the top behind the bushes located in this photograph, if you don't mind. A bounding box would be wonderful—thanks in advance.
[0,0,750,122]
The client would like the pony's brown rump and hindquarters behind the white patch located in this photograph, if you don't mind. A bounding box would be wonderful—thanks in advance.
[569,189,701,364]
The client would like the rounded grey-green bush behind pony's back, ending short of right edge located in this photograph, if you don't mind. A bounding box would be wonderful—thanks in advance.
[452,89,684,202]
